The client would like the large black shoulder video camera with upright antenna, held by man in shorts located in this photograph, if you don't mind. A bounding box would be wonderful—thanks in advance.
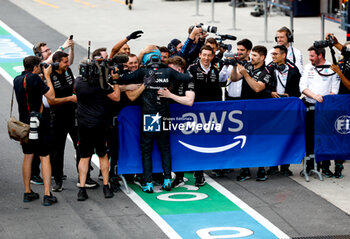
[79,41,129,89]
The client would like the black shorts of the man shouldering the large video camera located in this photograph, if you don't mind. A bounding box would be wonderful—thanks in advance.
[78,125,108,158]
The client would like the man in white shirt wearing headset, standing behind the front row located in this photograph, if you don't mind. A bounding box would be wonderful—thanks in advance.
[265,27,303,74]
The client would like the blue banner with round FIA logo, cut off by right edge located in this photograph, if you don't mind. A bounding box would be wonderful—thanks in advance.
[315,95,350,162]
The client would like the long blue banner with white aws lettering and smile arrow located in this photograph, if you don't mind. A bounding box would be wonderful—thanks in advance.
[118,98,305,174]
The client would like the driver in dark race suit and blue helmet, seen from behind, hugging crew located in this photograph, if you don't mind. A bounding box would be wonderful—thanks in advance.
[118,46,192,193]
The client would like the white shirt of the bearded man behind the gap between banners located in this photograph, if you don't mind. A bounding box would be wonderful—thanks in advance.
[299,61,340,104]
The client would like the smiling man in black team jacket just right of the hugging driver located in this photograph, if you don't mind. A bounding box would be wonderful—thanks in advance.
[187,46,223,187]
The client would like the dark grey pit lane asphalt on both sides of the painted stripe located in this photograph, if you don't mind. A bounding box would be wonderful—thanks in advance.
[0,0,350,238]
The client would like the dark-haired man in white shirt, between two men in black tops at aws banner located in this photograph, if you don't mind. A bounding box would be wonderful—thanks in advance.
[219,39,253,100]
